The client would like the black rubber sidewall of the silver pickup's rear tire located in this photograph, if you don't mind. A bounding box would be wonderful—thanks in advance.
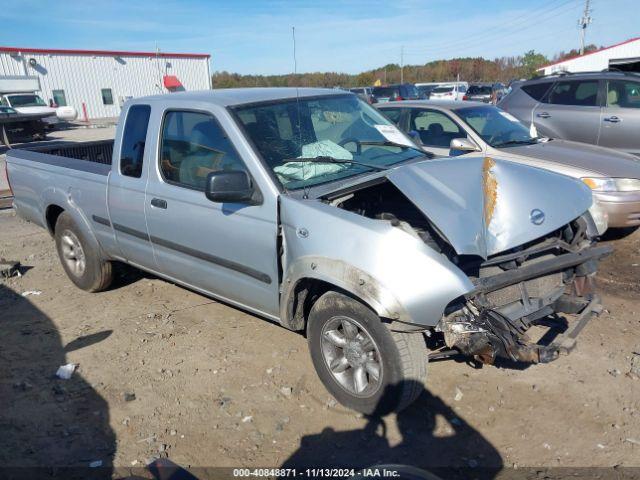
[55,212,101,291]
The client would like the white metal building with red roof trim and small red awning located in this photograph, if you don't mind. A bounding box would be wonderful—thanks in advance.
[0,47,211,120]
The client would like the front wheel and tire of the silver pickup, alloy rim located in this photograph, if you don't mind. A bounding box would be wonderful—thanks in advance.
[307,291,428,415]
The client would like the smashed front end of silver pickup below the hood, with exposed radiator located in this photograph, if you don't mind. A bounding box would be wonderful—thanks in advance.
[436,218,611,363]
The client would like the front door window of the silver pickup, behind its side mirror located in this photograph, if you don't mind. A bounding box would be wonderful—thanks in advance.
[160,111,245,190]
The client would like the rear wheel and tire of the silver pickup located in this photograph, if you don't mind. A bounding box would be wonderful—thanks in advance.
[55,212,113,292]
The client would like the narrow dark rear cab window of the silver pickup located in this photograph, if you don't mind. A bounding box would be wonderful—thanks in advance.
[120,105,151,178]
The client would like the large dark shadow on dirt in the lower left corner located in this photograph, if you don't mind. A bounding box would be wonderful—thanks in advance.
[0,284,116,479]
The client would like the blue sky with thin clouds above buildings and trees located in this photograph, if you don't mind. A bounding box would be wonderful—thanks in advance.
[0,0,640,74]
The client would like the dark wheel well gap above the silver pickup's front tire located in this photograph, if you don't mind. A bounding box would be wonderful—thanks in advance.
[283,278,375,330]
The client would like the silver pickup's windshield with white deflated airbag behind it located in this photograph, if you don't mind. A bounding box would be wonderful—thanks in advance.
[235,95,424,190]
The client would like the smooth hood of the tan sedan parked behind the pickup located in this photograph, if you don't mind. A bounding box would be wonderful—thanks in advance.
[501,139,640,178]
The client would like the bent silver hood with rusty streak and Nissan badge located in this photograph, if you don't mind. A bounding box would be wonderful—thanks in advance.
[387,157,592,259]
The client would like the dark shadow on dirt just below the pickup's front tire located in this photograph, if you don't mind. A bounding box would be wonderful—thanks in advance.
[282,385,503,480]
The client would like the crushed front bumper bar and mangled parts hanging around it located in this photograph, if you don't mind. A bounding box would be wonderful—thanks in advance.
[438,246,612,363]
